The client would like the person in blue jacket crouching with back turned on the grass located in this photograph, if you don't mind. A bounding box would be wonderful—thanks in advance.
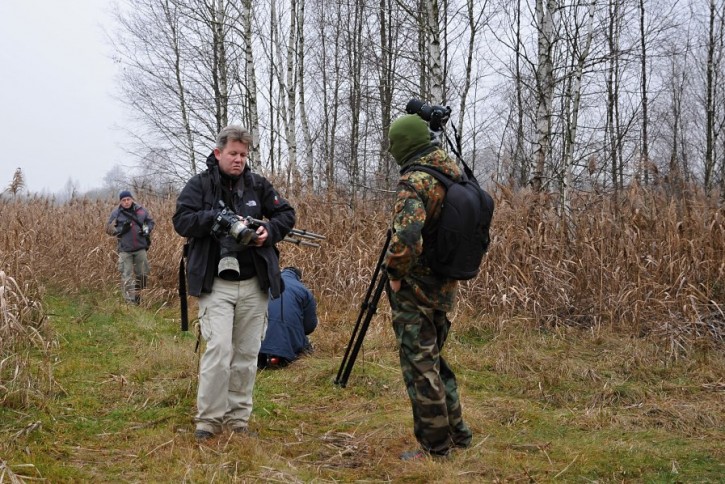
[258,267,317,368]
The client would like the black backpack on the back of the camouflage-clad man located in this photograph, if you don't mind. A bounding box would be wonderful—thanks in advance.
[404,165,494,280]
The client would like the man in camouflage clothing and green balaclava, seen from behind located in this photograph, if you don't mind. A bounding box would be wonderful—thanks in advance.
[385,115,472,460]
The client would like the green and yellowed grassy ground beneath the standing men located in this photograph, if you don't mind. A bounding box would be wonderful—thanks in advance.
[0,294,725,482]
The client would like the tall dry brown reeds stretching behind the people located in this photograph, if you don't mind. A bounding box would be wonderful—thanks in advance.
[0,186,725,362]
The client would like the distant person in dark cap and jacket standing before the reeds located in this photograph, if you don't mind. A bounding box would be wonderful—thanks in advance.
[106,190,155,304]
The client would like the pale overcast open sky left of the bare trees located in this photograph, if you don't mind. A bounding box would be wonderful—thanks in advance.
[0,0,128,193]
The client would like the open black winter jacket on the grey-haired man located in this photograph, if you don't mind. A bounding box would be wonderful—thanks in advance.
[172,153,295,298]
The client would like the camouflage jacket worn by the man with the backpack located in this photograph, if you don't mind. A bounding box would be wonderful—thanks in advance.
[384,147,462,311]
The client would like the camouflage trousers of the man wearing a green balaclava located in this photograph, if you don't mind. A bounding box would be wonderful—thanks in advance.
[388,282,472,454]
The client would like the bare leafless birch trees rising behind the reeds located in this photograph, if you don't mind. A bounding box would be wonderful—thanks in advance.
[111,0,725,204]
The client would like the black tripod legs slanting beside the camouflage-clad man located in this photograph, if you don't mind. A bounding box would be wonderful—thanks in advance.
[335,229,393,388]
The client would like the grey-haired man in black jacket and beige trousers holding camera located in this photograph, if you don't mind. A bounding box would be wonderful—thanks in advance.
[173,126,295,441]
